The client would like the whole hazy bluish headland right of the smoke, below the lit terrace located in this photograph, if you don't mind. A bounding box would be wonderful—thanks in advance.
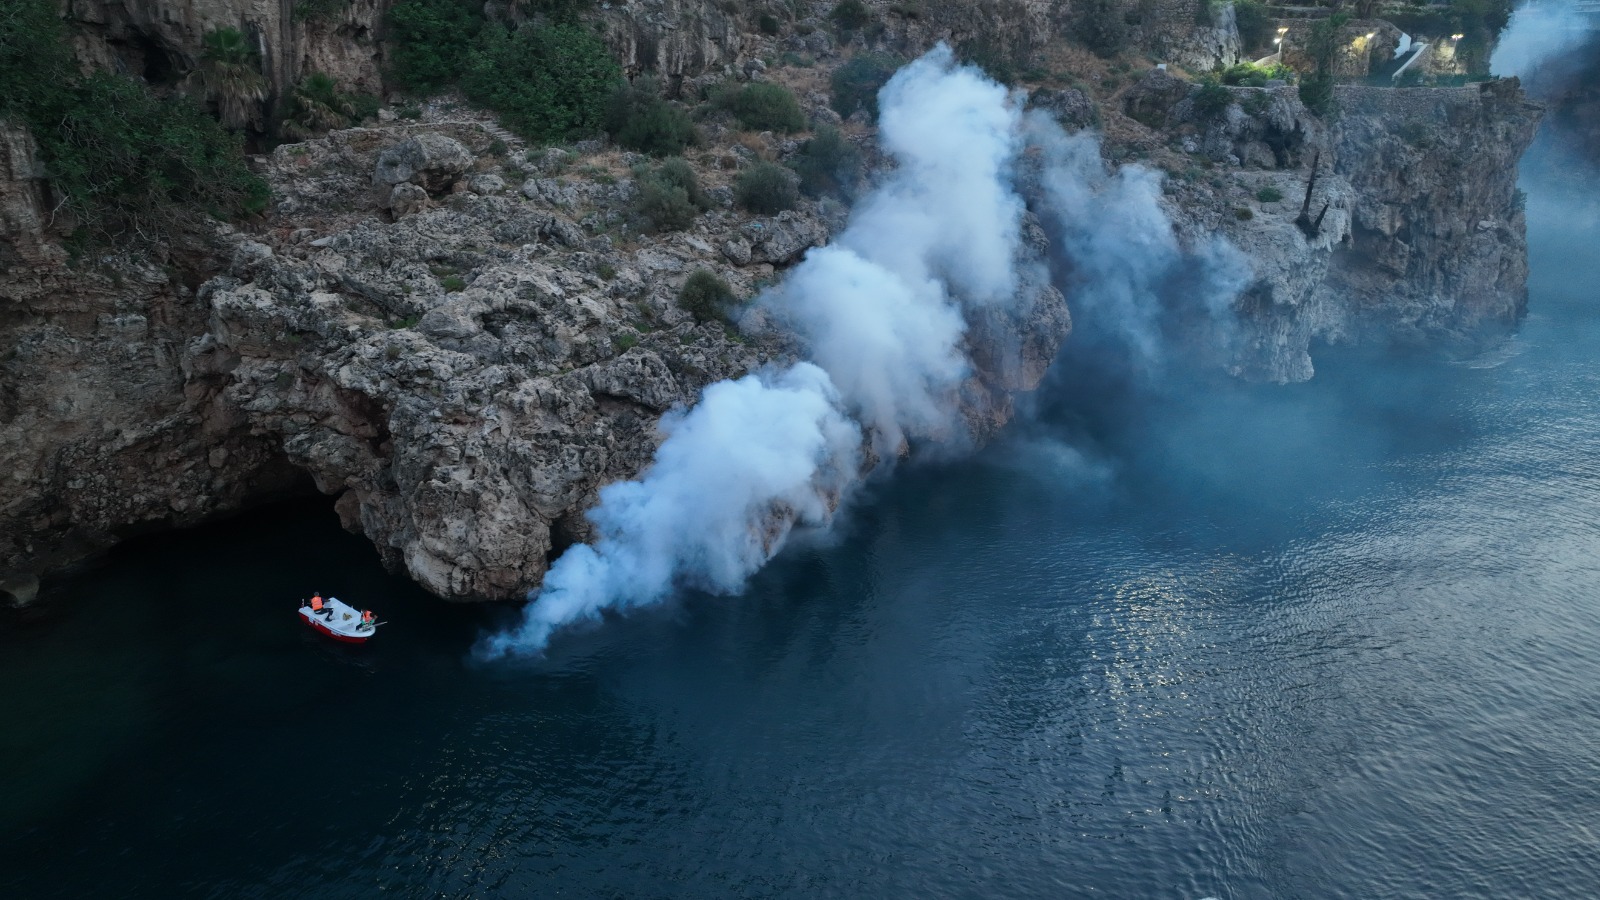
[1100,70,1541,381]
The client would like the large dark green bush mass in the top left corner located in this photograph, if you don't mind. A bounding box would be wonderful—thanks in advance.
[0,0,269,240]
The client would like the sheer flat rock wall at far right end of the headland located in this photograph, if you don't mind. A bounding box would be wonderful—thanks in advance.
[1322,78,1542,344]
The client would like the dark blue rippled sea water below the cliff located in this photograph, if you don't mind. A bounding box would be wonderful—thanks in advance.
[0,162,1600,900]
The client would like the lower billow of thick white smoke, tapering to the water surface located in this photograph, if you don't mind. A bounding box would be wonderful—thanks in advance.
[478,362,861,658]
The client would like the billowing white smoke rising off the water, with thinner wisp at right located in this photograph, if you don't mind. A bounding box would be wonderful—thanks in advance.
[478,45,1248,658]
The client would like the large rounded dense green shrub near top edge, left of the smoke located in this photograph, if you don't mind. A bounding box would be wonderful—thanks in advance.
[461,22,622,141]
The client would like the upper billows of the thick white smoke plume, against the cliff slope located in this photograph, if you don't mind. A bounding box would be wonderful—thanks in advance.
[762,45,1024,458]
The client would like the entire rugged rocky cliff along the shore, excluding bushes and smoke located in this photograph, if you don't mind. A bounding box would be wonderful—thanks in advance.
[0,0,1538,599]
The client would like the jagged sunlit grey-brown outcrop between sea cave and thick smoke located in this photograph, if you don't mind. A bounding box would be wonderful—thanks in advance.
[172,115,1070,599]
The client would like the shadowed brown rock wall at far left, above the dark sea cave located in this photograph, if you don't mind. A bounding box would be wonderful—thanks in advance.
[0,117,304,589]
